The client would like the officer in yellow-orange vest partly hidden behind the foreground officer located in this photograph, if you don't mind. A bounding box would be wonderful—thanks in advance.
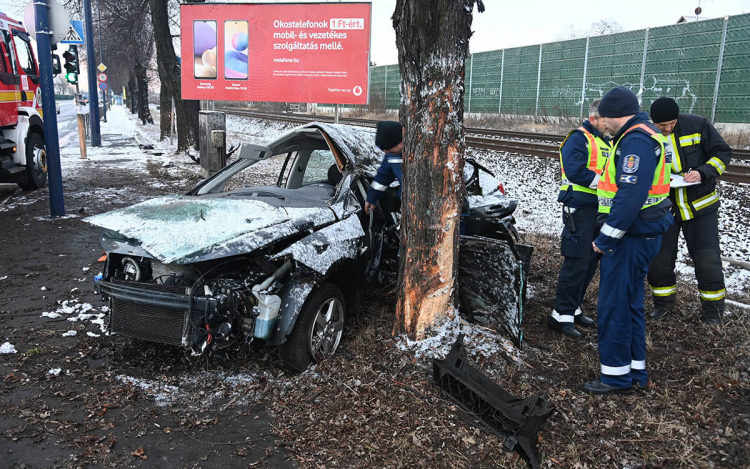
[547,100,610,338]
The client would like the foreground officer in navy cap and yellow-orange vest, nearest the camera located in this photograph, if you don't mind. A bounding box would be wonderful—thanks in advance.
[583,86,673,394]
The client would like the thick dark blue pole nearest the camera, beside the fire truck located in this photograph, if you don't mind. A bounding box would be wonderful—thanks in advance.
[34,0,65,217]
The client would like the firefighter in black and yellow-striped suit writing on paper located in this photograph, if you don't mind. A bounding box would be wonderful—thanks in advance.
[648,98,732,325]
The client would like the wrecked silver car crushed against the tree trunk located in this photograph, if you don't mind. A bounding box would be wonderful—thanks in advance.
[85,123,532,370]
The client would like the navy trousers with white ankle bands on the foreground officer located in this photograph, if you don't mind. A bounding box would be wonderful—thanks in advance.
[597,235,662,388]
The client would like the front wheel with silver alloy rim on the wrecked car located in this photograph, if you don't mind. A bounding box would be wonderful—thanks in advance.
[279,283,346,373]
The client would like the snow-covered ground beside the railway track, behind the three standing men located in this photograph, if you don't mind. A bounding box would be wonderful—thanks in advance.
[466,149,750,294]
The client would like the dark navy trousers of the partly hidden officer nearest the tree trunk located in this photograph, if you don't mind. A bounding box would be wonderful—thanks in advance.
[555,207,600,322]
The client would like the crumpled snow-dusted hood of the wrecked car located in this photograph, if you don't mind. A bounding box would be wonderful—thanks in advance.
[84,195,336,264]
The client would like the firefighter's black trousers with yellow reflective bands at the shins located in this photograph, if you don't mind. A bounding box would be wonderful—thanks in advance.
[648,210,726,319]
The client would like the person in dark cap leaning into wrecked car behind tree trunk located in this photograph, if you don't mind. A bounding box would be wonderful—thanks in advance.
[365,121,404,215]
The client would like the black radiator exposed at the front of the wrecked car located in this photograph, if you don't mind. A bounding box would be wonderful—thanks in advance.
[110,279,194,345]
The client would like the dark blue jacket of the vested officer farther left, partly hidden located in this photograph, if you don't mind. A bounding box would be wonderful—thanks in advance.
[557,121,609,208]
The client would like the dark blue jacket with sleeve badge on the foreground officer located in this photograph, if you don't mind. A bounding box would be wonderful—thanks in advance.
[594,112,674,253]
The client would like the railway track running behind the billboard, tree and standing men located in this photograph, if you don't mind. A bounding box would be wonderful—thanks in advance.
[217,108,750,184]
